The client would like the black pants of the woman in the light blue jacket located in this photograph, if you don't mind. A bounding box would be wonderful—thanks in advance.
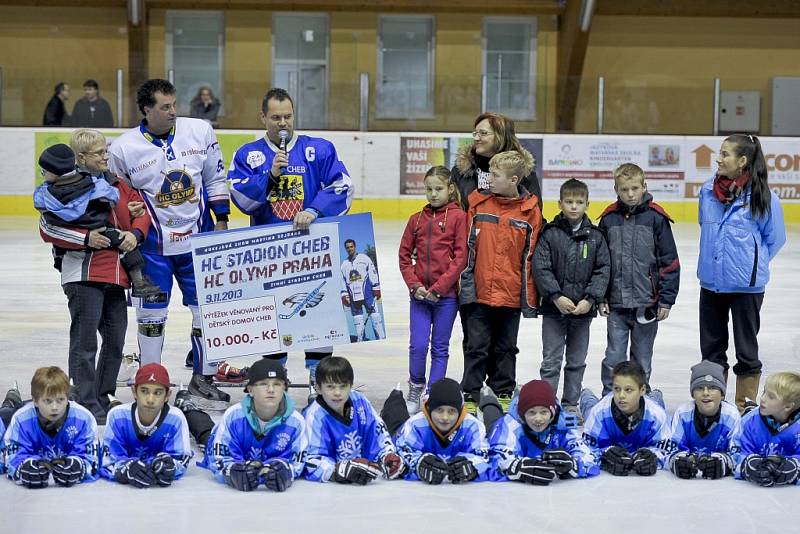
[700,289,764,375]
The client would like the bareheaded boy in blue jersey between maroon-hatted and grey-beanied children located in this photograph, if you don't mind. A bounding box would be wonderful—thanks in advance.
[581,361,669,476]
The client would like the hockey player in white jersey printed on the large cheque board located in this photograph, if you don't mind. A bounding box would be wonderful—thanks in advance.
[342,239,386,341]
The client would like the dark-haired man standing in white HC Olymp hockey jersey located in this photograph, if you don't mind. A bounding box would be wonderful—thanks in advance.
[109,79,230,410]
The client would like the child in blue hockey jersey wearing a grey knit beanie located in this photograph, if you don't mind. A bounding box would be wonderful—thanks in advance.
[667,360,741,480]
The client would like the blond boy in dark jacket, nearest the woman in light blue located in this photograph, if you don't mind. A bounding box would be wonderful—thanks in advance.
[599,163,680,395]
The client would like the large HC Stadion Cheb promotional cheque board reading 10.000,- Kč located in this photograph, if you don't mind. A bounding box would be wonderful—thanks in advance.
[191,213,386,362]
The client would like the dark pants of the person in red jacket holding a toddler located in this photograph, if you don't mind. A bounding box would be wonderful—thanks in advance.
[62,282,128,416]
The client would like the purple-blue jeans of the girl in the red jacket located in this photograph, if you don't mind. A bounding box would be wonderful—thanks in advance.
[408,297,458,389]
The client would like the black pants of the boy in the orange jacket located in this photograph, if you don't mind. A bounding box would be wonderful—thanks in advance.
[461,304,520,402]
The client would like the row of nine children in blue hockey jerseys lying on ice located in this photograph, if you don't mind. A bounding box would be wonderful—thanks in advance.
[3,357,800,491]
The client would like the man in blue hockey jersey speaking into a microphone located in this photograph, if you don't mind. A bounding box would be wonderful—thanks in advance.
[228,88,353,394]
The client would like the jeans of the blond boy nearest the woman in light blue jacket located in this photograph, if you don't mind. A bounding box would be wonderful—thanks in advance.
[600,309,658,396]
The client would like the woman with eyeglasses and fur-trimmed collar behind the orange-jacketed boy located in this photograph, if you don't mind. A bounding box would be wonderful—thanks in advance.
[450,113,542,211]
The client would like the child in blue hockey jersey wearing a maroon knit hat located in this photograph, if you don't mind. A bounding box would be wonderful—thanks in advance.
[489,380,600,486]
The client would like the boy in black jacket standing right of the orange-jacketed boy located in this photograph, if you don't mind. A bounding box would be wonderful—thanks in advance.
[533,179,611,415]
